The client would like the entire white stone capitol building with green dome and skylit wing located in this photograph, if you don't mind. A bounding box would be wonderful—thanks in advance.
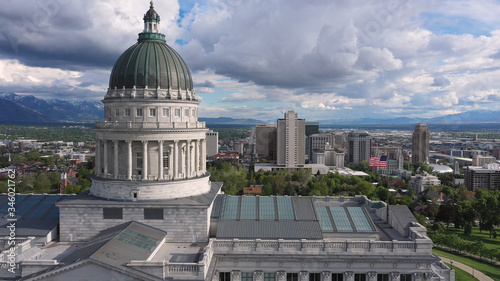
[3,3,455,281]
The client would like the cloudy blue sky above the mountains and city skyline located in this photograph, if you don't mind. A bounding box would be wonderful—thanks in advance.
[0,0,500,121]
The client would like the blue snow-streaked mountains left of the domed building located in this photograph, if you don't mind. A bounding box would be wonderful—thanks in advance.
[0,93,104,123]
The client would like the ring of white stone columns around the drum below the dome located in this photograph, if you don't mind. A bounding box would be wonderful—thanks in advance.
[95,139,206,180]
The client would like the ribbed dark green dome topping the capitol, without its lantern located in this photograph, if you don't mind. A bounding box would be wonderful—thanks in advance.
[109,40,193,91]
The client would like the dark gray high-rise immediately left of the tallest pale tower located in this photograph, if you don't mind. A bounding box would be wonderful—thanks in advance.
[254,124,278,162]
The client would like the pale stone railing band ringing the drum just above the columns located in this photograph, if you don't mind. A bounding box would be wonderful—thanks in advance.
[96,121,205,129]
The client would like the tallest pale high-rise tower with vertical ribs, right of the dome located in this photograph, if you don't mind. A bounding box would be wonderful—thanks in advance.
[277,110,306,167]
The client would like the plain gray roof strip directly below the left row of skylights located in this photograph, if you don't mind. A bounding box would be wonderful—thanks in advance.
[217,220,323,239]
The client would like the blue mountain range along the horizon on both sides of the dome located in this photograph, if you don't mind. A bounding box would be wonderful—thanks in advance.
[0,92,500,126]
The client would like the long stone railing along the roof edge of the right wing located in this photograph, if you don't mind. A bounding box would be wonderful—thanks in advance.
[211,239,432,255]
